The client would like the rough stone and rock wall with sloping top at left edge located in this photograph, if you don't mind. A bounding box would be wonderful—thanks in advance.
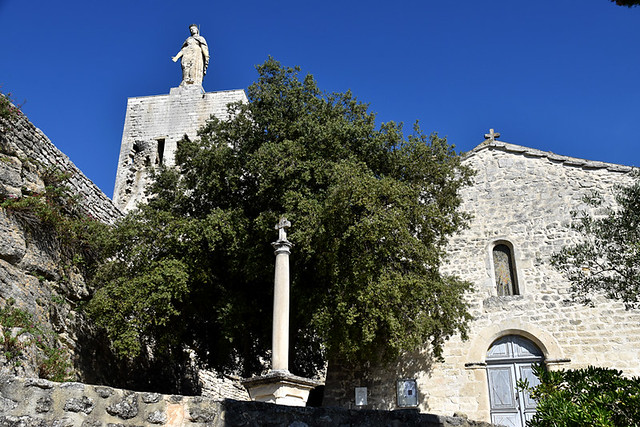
[0,109,122,381]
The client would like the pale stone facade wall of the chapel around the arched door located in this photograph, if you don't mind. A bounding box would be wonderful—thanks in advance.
[325,141,640,421]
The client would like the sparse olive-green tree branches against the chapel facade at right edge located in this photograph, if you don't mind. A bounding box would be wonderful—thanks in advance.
[552,174,640,307]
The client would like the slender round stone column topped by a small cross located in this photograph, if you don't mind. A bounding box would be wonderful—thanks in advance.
[271,222,292,371]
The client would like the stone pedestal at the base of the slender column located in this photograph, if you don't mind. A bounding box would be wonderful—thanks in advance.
[242,371,321,406]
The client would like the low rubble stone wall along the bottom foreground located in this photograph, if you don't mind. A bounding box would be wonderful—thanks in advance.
[0,376,490,427]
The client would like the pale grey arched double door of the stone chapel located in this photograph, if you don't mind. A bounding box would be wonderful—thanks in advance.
[486,335,544,427]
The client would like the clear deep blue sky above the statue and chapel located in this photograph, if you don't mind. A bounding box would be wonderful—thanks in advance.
[0,0,640,196]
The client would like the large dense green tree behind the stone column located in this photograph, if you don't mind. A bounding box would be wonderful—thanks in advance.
[89,59,471,375]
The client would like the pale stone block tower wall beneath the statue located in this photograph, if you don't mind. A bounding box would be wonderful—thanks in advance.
[113,85,247,212]
